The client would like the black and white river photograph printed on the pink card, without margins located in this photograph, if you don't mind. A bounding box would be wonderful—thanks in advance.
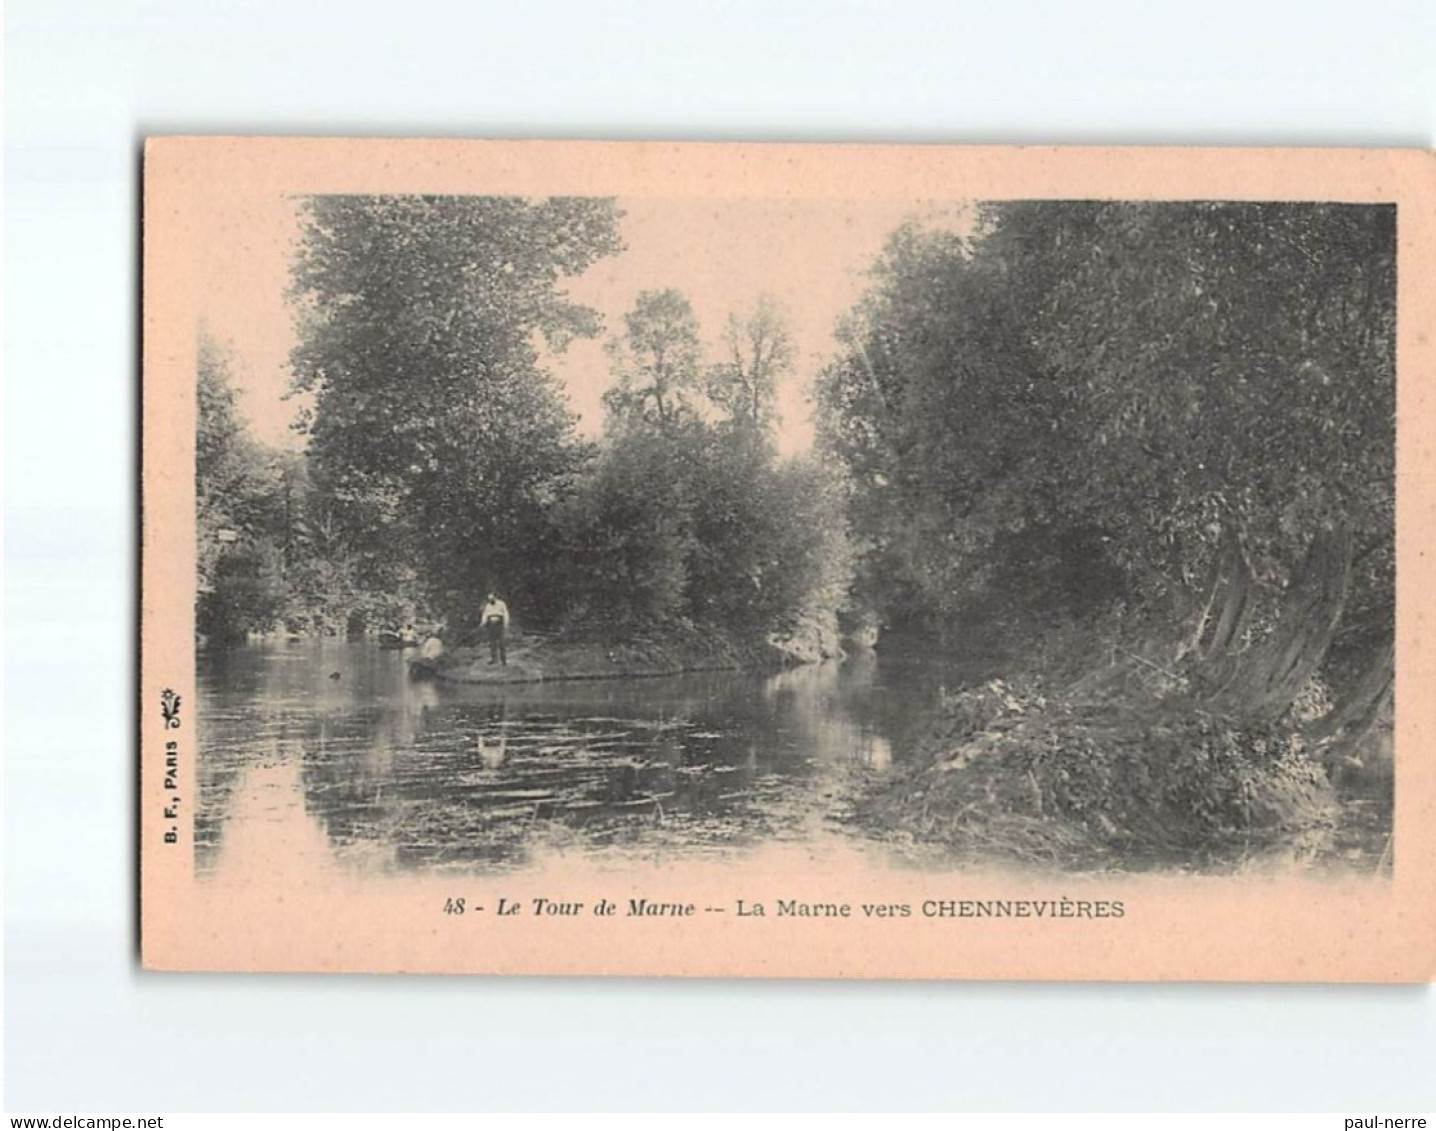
[185,188,1399,876]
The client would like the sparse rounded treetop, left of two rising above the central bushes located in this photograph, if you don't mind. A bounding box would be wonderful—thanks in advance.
[603,290,702,428]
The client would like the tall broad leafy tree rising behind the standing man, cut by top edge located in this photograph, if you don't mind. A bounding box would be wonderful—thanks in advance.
[292,189,620,621]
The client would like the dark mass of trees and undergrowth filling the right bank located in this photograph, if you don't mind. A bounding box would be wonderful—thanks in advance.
[820,202,1396,848]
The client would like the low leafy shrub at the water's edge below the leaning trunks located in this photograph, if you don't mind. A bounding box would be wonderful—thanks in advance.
[867,682,1334,865]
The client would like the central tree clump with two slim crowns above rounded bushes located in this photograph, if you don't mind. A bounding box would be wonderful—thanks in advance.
[564,290,847,642]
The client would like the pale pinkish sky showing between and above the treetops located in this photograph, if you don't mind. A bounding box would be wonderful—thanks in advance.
[197,195,969,455]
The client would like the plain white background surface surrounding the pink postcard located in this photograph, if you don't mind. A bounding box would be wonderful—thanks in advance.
[3,0,1436,1114]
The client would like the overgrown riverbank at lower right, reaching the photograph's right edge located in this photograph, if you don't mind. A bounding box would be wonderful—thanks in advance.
[857,645,1390,871]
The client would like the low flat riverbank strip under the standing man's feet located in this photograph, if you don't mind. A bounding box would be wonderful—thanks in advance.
[409,624,841,685]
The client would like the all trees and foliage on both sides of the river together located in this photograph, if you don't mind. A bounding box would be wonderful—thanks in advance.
[197,197,1396,861]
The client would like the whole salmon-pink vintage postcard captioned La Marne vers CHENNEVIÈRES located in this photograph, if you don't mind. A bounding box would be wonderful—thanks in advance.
[138,138,1436,982]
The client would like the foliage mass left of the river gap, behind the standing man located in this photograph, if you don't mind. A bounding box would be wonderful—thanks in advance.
[198,197,847,652]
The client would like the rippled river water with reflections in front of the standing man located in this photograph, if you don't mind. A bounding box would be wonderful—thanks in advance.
[195,640,987,874]
